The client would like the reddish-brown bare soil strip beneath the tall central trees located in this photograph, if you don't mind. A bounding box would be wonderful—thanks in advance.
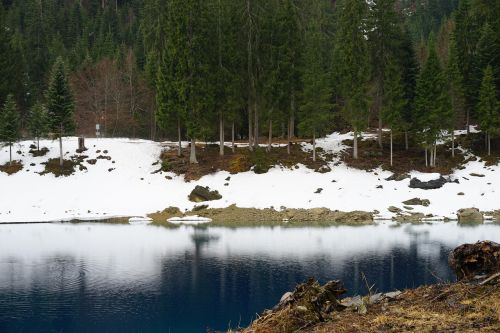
[160,140,327,181]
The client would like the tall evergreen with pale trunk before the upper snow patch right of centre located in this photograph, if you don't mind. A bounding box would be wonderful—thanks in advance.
[334,0,369,159]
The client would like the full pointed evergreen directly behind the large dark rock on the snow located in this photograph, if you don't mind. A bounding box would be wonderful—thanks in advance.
[415,36,451,167]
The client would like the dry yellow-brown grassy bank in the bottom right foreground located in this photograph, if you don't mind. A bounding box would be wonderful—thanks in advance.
[232,276,500,333]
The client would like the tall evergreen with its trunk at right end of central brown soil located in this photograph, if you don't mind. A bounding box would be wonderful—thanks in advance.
[299,0,333,161]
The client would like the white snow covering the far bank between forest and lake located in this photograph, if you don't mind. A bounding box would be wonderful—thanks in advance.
[0,133,500,222]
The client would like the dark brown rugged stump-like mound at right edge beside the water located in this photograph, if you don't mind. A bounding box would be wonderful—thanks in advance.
[448,241,500,280]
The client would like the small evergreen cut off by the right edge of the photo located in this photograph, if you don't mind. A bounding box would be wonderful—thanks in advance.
[477,66,500,156]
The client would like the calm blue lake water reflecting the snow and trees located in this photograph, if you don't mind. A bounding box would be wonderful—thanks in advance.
[0,223,500,333]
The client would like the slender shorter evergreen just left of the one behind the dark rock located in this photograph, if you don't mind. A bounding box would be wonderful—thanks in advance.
[381,62,407,166]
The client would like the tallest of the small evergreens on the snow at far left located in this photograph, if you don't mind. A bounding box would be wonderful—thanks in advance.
[45,57,75,167]
